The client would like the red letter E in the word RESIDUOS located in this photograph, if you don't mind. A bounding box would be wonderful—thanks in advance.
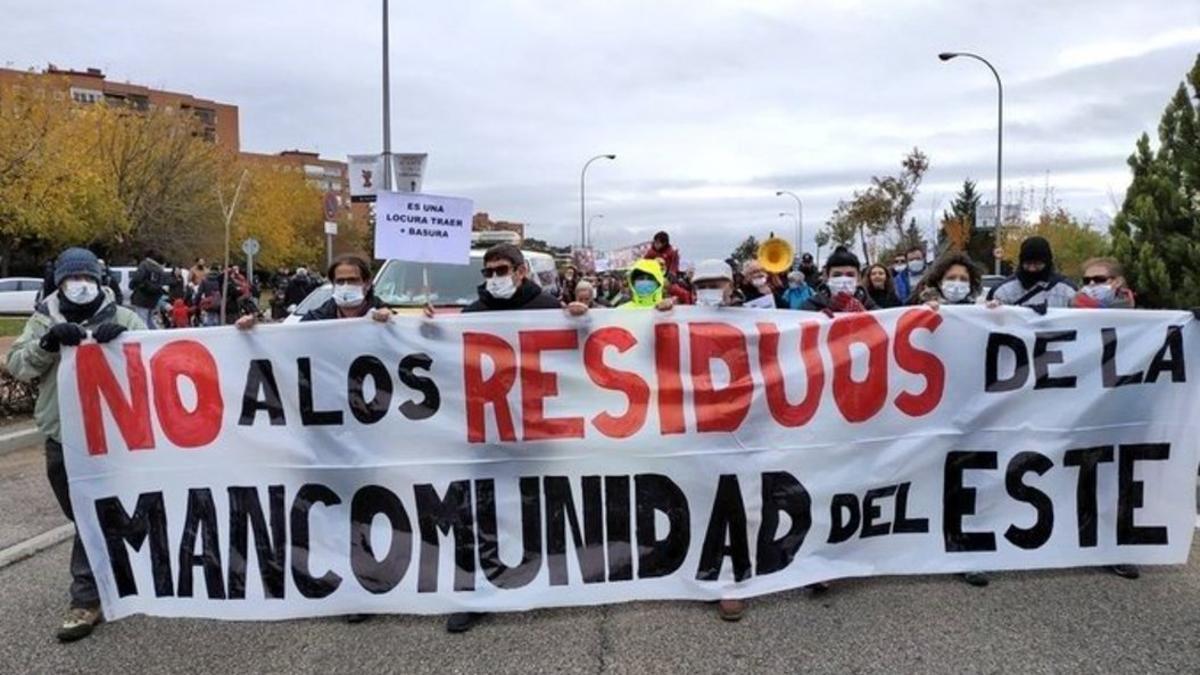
[520,328,583,441]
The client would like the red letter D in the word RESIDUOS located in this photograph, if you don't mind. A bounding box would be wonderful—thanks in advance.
[688,323,754,432]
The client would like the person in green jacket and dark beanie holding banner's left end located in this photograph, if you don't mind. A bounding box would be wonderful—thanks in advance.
[6,243,146,643]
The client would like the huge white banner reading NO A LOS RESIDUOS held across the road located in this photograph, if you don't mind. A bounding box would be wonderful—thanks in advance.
[58,306,1200,620]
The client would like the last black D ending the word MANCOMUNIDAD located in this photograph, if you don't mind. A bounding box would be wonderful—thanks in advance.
[755,471,812,577]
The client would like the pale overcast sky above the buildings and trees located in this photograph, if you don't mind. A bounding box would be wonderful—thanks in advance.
[7,0,1200,259]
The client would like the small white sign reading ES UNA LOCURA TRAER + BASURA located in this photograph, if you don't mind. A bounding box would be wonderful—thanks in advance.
[374,192,475,264]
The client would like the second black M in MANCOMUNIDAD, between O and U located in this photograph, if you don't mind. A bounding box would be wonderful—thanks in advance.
[413,480,475,593]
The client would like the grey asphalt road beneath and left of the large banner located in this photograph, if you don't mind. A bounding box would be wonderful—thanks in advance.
[0,439,1200,673]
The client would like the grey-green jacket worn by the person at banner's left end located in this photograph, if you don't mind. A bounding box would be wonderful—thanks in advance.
[5,287,146,442]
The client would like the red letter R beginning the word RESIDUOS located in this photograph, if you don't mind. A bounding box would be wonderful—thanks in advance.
[462,333,517,443]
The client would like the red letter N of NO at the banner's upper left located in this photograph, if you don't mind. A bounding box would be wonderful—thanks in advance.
[76,342,154,455]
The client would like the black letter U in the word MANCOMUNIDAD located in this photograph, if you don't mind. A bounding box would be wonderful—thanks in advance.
[475,476,541,589]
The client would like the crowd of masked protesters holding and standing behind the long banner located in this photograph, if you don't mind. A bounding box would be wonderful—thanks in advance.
[6,224,1171,641]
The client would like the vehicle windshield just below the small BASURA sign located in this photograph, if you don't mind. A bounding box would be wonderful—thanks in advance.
[374,258,484,306]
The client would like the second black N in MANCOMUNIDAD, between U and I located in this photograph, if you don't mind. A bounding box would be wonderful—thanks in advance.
[542,476,605,586]
